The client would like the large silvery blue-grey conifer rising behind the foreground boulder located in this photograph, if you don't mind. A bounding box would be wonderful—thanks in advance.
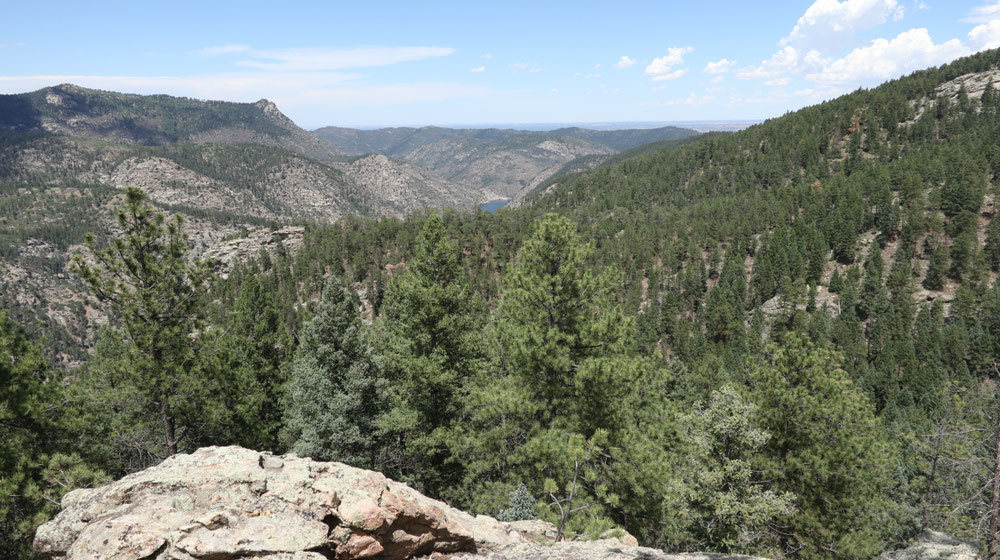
[283,277,386,469]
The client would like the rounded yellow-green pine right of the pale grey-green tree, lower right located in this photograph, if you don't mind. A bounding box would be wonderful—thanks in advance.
[750,334,896,559]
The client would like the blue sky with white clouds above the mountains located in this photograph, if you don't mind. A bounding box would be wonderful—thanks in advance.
[0,0,1000,129]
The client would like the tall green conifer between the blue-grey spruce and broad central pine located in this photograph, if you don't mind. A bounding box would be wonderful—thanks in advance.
[376,213,486,495]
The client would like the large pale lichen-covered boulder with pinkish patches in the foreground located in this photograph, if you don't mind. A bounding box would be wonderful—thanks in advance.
[35,447,525,560]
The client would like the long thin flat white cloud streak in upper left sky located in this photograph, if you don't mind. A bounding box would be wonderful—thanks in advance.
[236,47,455,71]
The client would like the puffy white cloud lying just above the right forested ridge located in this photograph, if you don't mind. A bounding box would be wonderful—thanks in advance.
[806,28,969,86]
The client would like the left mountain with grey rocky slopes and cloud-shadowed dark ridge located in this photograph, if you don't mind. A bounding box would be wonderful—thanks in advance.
[0,85,493,361]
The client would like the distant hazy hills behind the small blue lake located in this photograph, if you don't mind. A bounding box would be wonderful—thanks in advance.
[313,126,696,198]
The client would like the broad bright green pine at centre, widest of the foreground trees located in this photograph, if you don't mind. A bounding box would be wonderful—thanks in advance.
[462,214,672,531]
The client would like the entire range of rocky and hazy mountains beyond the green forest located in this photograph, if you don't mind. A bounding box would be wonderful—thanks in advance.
[0,84,694,359]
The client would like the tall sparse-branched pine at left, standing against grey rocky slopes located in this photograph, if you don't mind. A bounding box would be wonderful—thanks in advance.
[73,188,218,456]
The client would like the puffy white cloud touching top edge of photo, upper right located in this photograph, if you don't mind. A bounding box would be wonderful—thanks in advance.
[778,0,904,51]
